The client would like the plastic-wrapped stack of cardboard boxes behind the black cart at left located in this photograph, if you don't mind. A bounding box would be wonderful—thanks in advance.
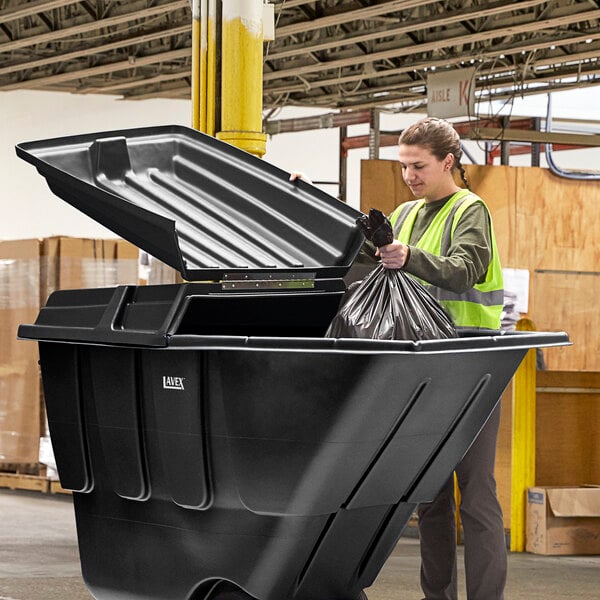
[0,236,139,464]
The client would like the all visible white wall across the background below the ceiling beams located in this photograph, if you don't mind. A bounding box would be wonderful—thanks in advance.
[0,87,600,239]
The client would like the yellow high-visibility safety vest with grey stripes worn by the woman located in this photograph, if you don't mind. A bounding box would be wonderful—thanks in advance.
[390,190,504,329]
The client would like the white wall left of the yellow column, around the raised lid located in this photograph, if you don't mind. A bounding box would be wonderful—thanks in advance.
[0,90,191,239]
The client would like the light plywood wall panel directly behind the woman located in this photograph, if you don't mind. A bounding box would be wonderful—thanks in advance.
[361,160,600,371]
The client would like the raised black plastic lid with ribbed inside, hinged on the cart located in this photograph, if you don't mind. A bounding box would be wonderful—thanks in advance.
[16,126,364,281]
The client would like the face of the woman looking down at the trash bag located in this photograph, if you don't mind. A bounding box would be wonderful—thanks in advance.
[398,144,456,201]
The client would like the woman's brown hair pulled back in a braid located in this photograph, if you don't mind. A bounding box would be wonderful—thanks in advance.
[398,117,469,187]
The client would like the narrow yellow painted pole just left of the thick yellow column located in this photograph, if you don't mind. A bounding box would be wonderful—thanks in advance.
[192,0,207,132]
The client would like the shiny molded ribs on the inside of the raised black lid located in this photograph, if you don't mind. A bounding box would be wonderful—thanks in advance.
[91,149,350,269]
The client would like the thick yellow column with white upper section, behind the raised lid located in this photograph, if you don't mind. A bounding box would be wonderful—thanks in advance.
[217,0,267,156]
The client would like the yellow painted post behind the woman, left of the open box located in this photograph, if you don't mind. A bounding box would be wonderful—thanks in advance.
[510,319,536,552]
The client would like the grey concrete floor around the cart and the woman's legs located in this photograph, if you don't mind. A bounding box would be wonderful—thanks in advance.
[0,489,600,600]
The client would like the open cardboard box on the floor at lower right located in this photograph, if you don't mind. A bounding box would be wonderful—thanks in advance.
[526,486,600,555]
